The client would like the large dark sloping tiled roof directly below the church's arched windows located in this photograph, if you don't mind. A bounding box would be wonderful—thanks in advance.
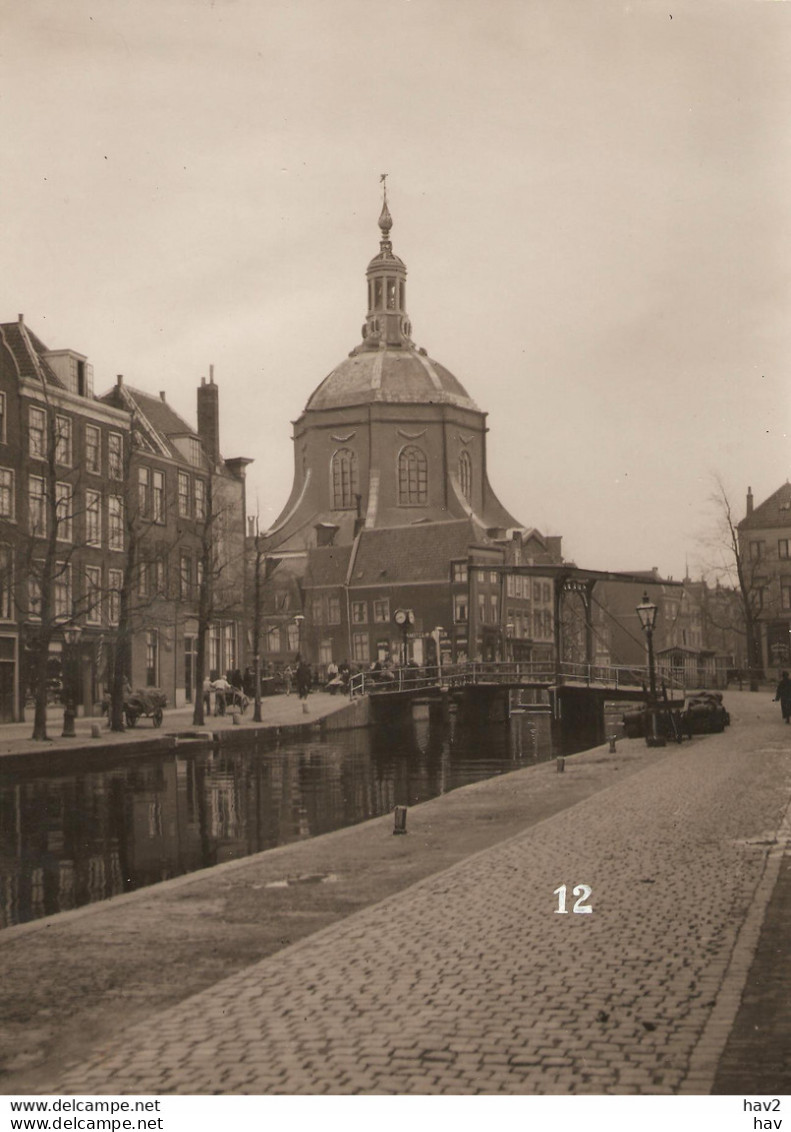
[351,518,488,586]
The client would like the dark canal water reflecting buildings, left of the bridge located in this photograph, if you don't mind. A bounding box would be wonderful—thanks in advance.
[0,714,551,927]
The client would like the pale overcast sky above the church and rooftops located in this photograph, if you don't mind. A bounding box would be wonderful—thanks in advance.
[0,0,791,577]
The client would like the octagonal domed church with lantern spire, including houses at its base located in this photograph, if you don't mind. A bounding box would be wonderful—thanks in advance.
[249,197,561,668]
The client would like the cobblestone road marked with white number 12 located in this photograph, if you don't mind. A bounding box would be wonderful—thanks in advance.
[57,711,791,1094]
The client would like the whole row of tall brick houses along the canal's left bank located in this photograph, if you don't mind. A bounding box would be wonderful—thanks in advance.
[0,315,249,721]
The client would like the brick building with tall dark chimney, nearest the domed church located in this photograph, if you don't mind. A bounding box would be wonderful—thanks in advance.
[101,375,250,706]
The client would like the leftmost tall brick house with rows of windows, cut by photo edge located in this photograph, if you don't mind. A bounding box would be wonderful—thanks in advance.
[0,315,129,721]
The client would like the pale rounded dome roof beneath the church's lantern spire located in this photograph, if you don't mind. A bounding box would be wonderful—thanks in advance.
[306,346,480,412]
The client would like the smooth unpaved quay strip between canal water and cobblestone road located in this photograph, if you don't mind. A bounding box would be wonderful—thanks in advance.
[0,697,746,1094]
